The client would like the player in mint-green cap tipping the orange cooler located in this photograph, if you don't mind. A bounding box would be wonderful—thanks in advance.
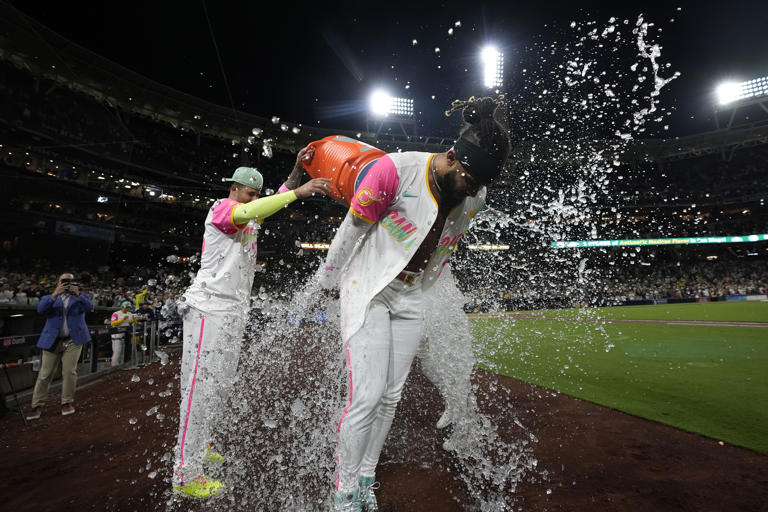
[172,150,328,499]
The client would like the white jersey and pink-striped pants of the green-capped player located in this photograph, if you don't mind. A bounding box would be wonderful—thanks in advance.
[173,199,259,485]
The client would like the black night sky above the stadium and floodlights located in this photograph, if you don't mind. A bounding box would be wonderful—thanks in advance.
[11,0,768,135]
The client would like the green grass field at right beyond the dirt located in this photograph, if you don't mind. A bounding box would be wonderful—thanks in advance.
[472,302,768,454]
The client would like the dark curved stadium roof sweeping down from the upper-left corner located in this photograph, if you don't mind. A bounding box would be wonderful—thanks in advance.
[0,2,453,151]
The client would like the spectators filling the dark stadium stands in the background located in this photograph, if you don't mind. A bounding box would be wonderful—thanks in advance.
[0,56,768,318]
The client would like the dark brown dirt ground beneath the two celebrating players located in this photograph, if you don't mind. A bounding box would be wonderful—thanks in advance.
[0,346,768,512]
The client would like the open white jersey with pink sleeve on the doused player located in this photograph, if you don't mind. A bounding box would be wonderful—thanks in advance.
[339,152,486,340]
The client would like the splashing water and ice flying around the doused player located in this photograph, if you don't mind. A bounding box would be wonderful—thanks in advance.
[160,10,678,511]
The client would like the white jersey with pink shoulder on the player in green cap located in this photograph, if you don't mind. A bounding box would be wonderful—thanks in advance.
[184,199,259,312]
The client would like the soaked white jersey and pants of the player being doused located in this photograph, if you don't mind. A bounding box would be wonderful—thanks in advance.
[309,138,485,492]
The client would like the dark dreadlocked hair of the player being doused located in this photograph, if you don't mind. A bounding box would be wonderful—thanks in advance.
[445,94,512,159]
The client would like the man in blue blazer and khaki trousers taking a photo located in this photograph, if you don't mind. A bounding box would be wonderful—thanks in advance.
[27,274,93,420]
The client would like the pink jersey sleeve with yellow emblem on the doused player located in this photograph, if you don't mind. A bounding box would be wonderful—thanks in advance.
[349,155,400,223]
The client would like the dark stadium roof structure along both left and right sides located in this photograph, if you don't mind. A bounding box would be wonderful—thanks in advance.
[0,2,768,168]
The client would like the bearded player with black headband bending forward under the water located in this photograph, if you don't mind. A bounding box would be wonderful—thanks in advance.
[320,98,510,511]
